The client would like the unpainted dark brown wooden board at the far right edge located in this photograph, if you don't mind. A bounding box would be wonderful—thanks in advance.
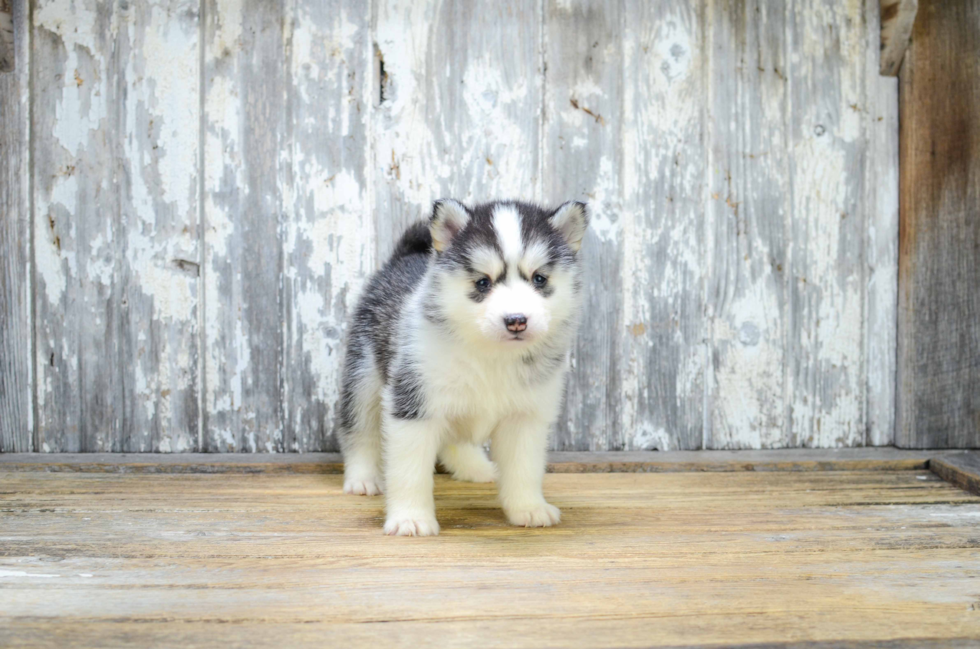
[896,0,980,448]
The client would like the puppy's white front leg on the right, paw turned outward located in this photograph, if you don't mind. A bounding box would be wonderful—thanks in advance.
[490,416,561,527]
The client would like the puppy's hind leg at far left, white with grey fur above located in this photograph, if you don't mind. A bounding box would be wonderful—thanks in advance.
[340,368,384,496]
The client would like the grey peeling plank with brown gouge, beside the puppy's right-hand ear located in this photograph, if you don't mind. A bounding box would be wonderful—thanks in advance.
[542,0,620,450]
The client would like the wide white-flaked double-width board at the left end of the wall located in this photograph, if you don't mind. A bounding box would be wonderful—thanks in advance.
[31,0,199,451]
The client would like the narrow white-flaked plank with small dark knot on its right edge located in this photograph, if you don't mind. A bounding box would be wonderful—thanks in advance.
[118,0,201,452]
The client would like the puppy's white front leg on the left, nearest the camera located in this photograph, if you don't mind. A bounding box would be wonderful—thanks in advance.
[383,415,445,536]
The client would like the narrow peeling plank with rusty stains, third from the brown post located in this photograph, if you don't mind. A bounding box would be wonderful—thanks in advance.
[705,0,788,449]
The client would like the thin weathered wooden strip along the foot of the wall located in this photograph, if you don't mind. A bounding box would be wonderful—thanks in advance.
[0,448,957,474]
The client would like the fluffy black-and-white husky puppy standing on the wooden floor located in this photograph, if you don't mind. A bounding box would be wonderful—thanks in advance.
[340,200,588,536]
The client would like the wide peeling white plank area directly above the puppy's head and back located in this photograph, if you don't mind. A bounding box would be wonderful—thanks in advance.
[373,0,542,262]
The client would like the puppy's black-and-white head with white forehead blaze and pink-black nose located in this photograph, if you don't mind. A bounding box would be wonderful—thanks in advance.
[429,200,589,349]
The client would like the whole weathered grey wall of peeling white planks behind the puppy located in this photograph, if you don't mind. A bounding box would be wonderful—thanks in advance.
[0,0,898,452]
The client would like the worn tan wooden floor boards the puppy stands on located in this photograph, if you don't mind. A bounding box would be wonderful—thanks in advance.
[0,469,980,649]
